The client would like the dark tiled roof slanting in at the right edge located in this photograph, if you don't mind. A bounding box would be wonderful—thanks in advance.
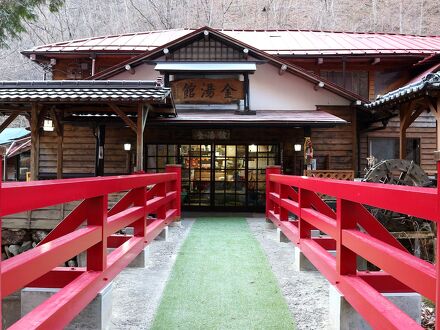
[364,73,440,109]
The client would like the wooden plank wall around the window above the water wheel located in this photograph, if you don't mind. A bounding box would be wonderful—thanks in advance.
[360,112,437,175]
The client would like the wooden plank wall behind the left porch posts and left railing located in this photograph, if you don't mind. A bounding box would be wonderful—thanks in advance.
[3,124,136,230]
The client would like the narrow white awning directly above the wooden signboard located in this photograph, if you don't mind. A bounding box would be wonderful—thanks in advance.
[154,62,257,73]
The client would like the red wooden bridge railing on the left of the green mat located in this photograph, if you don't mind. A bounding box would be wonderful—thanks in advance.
[0,165,181,329]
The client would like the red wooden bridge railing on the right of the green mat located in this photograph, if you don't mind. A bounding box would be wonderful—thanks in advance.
[266,163,440,329]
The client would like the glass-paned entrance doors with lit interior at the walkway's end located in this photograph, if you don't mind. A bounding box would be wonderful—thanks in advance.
[146,143,280,211]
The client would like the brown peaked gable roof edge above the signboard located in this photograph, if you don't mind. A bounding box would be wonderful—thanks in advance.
[88,27,368,102]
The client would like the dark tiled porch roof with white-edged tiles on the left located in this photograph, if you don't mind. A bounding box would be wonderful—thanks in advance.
[0,80,171,103]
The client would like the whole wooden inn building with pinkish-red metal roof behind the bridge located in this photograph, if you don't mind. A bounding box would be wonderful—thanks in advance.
[0,27,440,227]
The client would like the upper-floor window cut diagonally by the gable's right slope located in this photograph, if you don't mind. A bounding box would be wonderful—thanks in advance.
[320,70,368,99]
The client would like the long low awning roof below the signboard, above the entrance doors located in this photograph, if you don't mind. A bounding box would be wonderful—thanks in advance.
[147,110,347,126]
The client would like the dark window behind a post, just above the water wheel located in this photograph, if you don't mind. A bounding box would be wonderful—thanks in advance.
[369,138,420,164]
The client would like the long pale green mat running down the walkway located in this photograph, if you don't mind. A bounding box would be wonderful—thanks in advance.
[153,218,295,329]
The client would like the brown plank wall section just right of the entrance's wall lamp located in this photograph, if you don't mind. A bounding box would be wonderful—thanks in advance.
[312,107,357,170]
